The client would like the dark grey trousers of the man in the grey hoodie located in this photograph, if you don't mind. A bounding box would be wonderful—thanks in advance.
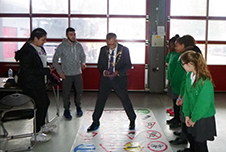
[62,74,83,110]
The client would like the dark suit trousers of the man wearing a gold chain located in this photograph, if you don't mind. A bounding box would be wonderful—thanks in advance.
[93,76,136,123]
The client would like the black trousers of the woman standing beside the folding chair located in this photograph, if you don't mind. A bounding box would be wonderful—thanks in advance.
[23,89,50,132]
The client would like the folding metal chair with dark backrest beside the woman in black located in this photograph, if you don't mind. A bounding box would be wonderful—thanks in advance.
[0,93,36,151]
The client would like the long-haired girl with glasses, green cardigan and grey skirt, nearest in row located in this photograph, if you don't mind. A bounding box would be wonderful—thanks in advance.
[181,51,216,152]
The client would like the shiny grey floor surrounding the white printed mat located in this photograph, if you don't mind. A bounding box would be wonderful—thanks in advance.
[0,92,226,152]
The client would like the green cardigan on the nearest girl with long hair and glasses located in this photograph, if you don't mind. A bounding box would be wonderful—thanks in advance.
[183,72,216,122]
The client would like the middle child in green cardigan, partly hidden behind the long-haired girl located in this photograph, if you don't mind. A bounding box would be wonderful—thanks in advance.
[166,35,195,129]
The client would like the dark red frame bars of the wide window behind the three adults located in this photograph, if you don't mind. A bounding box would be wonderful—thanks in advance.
[0,0,149,64]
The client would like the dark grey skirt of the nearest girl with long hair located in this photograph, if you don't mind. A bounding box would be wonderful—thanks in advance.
[187,116,217,142]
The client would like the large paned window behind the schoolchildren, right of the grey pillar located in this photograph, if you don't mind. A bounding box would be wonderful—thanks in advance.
[168,0,226,65]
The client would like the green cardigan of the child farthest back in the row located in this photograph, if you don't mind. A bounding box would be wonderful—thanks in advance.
[166,51,180,81]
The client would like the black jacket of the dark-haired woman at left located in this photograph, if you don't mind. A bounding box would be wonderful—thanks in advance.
[15,43,50,90]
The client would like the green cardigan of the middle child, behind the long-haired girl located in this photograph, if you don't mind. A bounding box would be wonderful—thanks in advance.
[169,54,187,95]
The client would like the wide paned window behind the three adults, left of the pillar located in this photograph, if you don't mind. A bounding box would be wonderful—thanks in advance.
[0,0,148,64]
